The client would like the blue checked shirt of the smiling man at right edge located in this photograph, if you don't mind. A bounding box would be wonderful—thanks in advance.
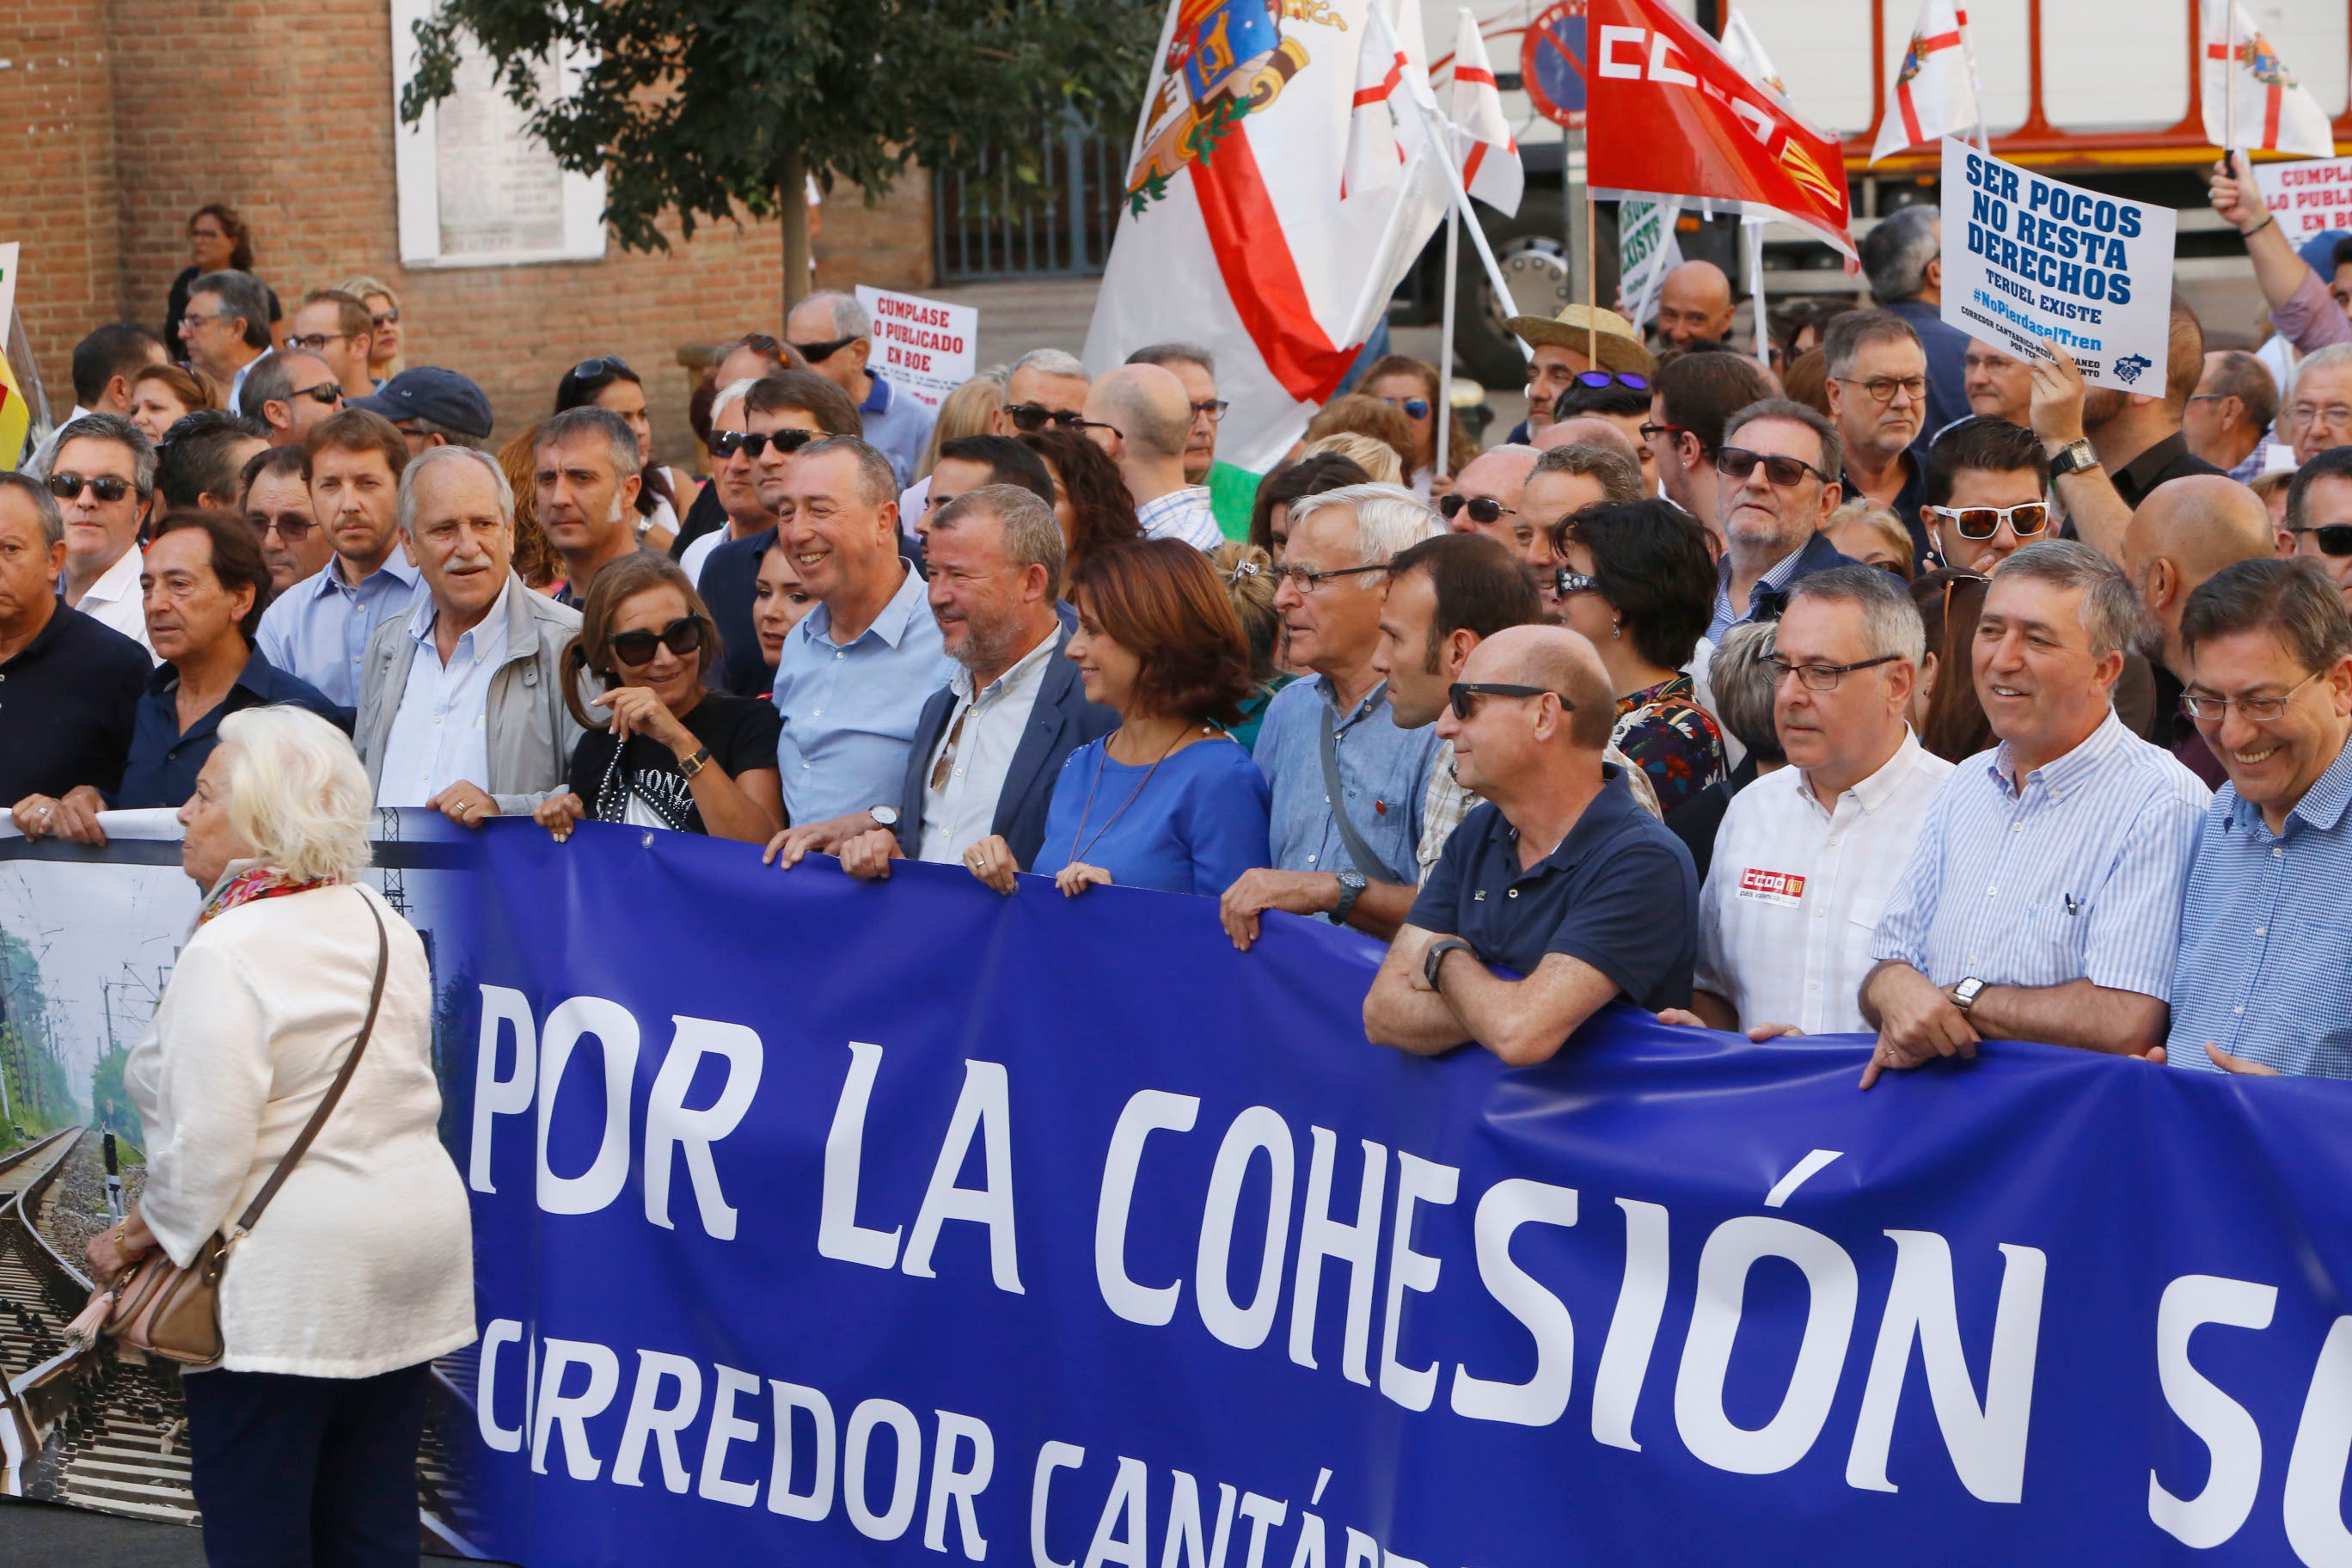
[2164,745,2352,1079]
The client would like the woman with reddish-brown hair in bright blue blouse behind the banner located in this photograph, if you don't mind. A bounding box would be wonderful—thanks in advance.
[965,538,1270,898]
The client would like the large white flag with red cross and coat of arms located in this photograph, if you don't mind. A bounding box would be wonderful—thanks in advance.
[1084,0,1449,482]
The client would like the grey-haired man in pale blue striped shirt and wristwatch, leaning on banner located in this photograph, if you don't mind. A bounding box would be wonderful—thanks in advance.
[1860,541,2211,1088]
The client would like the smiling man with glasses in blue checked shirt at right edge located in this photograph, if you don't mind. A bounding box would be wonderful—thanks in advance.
[2166,560,2352,1079]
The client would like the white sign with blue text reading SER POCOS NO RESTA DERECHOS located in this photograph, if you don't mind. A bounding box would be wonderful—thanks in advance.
[1943,137,2176,397]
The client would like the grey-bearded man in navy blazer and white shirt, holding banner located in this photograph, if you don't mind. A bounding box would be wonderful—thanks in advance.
[769,484,1119,877]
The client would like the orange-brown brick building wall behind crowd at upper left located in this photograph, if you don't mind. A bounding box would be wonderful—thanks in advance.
[0,0,931,461]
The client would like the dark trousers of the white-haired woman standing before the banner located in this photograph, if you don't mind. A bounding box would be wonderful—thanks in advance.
[183,1361,432,1568]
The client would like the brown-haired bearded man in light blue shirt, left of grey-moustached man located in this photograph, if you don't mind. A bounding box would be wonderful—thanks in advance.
[254,409,428,707]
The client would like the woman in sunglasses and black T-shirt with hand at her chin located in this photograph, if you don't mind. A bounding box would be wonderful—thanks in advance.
[534,550,783,844]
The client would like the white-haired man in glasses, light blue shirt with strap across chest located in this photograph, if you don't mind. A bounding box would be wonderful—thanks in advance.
[1221,484,1444,952]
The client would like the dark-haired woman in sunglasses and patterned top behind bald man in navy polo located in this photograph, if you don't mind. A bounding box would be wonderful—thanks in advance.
[1553,500,1724,811]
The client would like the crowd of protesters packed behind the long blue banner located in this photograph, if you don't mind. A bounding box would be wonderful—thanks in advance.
[0,172,2352,1560]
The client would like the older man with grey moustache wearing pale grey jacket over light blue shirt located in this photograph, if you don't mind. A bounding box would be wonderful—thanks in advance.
[352,447,581,828]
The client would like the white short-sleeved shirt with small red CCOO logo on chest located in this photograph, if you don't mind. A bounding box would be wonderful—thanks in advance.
[1694,731,1952,1034]
